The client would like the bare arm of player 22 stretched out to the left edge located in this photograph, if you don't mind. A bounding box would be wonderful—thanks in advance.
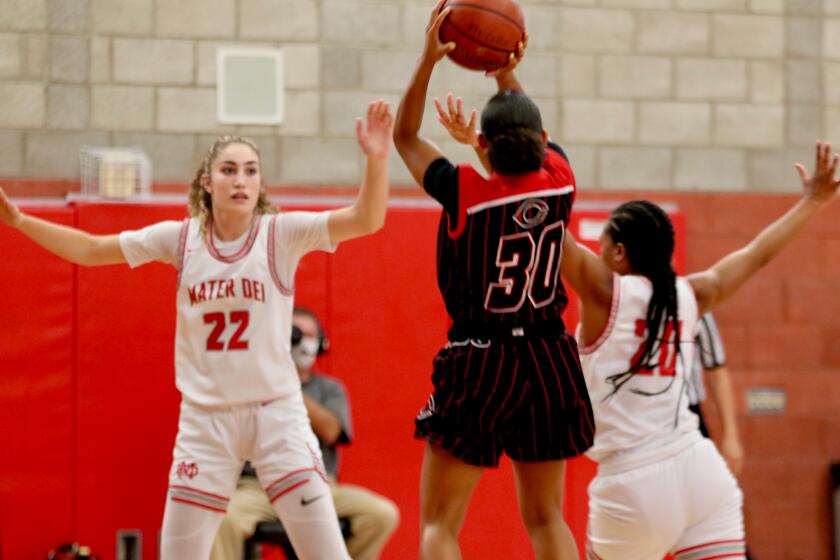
[0,188,126,266]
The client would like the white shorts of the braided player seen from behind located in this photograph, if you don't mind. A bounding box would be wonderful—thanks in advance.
[587,439,745,560]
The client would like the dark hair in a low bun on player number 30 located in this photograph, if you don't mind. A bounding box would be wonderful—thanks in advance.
[481,90,545,175]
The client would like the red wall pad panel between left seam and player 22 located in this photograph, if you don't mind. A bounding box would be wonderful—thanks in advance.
[77,204,185,560]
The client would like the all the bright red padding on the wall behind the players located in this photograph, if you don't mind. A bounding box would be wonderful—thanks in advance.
[0,203,684,560]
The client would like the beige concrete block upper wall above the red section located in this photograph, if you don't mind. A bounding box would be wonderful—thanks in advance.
[0,0,840,191]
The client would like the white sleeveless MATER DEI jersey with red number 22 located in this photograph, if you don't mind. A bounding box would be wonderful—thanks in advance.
[175,216,300,406]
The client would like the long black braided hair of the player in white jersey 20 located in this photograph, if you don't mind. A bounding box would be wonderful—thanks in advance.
[606,200,680,396]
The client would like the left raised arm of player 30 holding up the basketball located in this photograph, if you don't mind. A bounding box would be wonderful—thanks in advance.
[394,0,455,185]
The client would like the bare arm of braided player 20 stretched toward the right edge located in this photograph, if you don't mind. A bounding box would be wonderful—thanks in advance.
[688,142,840,313]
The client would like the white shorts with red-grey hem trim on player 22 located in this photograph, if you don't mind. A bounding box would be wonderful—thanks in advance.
[169,394,326,512]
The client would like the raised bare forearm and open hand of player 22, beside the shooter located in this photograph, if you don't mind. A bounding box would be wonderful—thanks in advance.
[327,100,394,244]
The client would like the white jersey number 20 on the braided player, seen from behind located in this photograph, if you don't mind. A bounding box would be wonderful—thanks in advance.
[580,275,698,466]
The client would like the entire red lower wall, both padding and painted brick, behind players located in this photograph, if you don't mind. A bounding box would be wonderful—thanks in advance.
[0,193,840,560]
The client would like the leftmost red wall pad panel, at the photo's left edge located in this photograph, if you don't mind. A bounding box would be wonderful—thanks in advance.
[0,207,76,559]
